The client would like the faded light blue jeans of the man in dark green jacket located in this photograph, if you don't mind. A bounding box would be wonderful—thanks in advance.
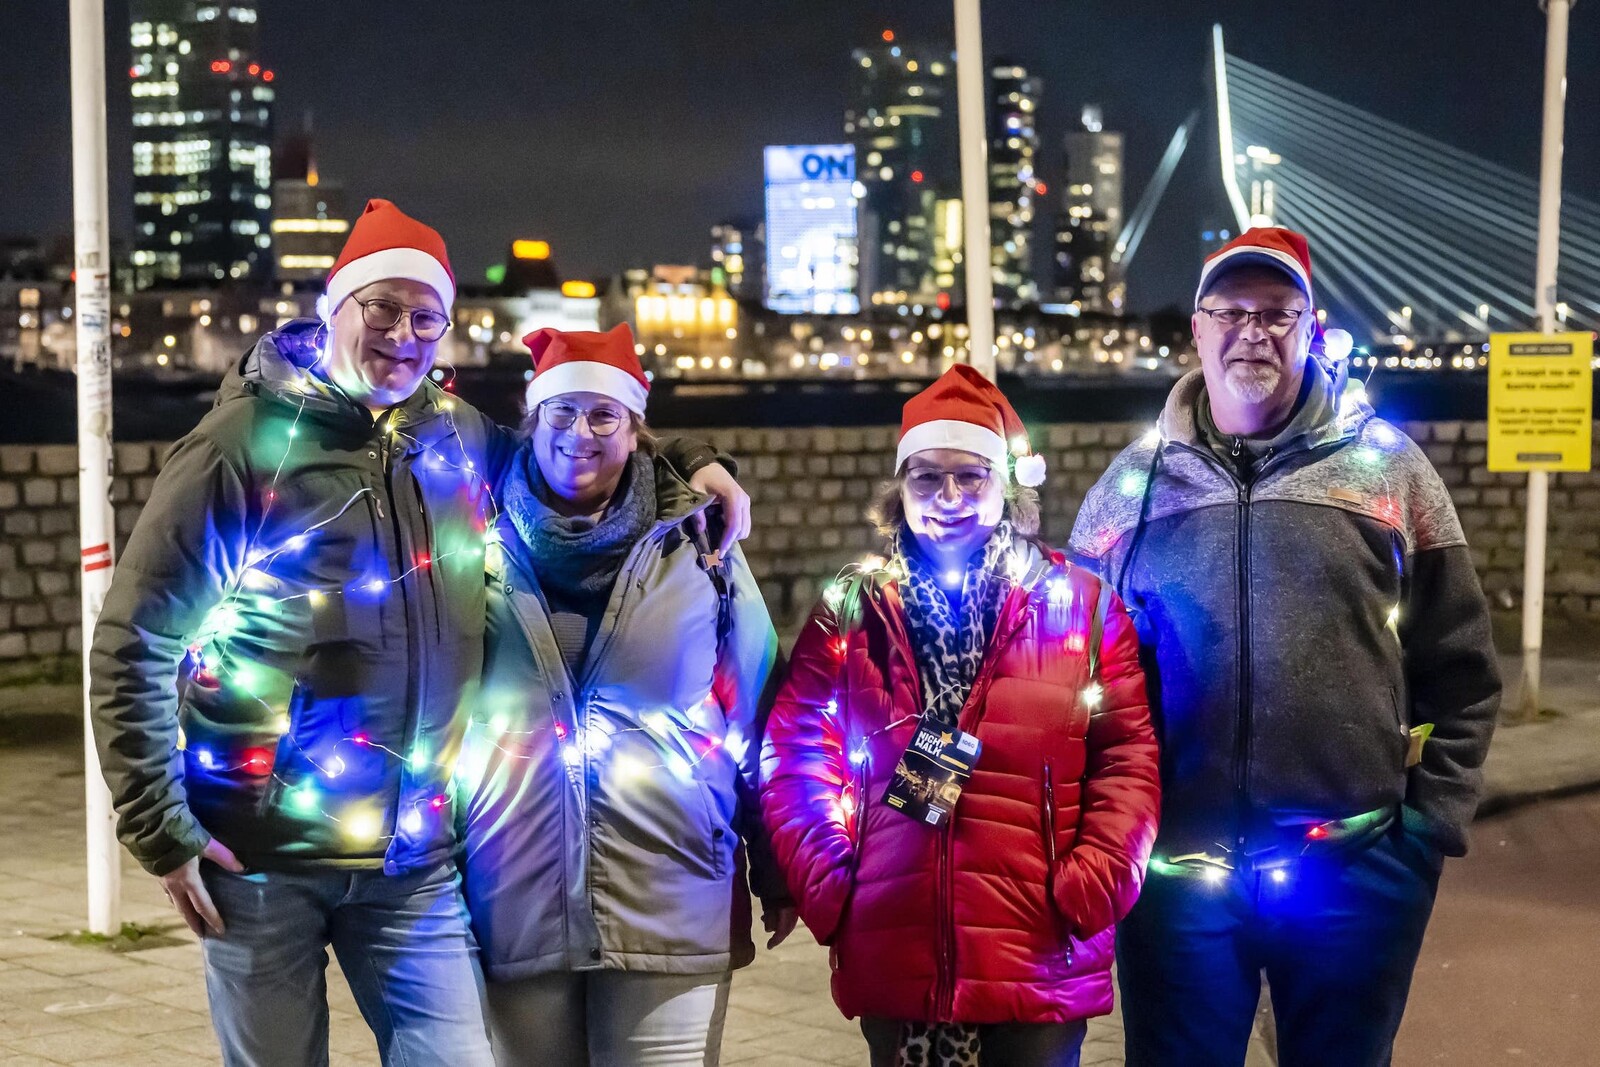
[200,862,494,1067]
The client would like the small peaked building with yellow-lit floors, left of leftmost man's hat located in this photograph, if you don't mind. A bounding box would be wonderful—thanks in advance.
[272,120,350,286]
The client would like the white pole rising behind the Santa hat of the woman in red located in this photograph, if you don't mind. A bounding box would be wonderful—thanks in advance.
[955,0,995,381]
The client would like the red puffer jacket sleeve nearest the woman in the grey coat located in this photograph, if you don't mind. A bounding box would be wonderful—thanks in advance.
[762,605,854,944]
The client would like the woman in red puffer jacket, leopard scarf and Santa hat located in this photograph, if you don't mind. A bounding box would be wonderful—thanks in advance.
[762,366,1160,1067]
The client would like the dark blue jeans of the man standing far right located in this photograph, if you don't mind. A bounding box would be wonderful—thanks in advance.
[1117,824,1443,1067]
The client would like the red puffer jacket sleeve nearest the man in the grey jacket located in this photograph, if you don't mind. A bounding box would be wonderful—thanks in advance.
[1056,597,1162,937]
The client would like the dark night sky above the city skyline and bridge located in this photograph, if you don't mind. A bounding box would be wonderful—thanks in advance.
[0,0,1600,310]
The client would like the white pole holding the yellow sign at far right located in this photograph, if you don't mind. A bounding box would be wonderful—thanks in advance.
[1518,0,1573,720]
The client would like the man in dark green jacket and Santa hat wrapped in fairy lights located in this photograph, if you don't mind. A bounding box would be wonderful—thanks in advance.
[90,200,742,1067]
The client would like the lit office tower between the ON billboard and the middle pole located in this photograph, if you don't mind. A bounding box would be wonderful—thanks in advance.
[845,30,960,307]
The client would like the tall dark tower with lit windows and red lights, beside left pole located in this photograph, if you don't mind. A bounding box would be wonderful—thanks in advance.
[128,0,274,288]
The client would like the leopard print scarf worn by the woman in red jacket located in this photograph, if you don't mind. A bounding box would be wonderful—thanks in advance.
[894,523,1014,1067]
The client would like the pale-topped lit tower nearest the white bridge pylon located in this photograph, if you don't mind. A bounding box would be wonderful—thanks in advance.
[1054,106,1126,315]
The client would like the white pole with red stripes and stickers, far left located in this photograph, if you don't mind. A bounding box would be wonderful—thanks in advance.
[70,0,122,934]
